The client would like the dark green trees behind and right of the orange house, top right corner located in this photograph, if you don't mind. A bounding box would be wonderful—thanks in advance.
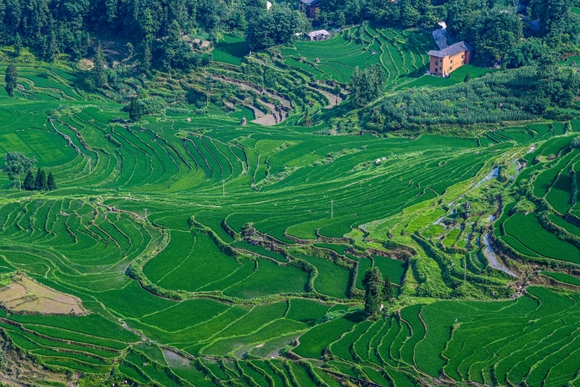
[445,0,580,67]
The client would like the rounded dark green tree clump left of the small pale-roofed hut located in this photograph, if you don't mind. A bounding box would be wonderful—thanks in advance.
[246,6,306,50]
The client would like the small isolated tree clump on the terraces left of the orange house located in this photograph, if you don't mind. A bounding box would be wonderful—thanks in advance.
[349,64,385,107]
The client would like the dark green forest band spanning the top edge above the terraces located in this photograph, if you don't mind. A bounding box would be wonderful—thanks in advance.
[0,0,580,72]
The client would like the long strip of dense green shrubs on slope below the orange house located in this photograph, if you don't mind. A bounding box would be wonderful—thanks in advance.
[365,65,580,131]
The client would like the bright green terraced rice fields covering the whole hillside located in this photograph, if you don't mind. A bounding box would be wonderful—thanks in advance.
[0,36,580,387]
